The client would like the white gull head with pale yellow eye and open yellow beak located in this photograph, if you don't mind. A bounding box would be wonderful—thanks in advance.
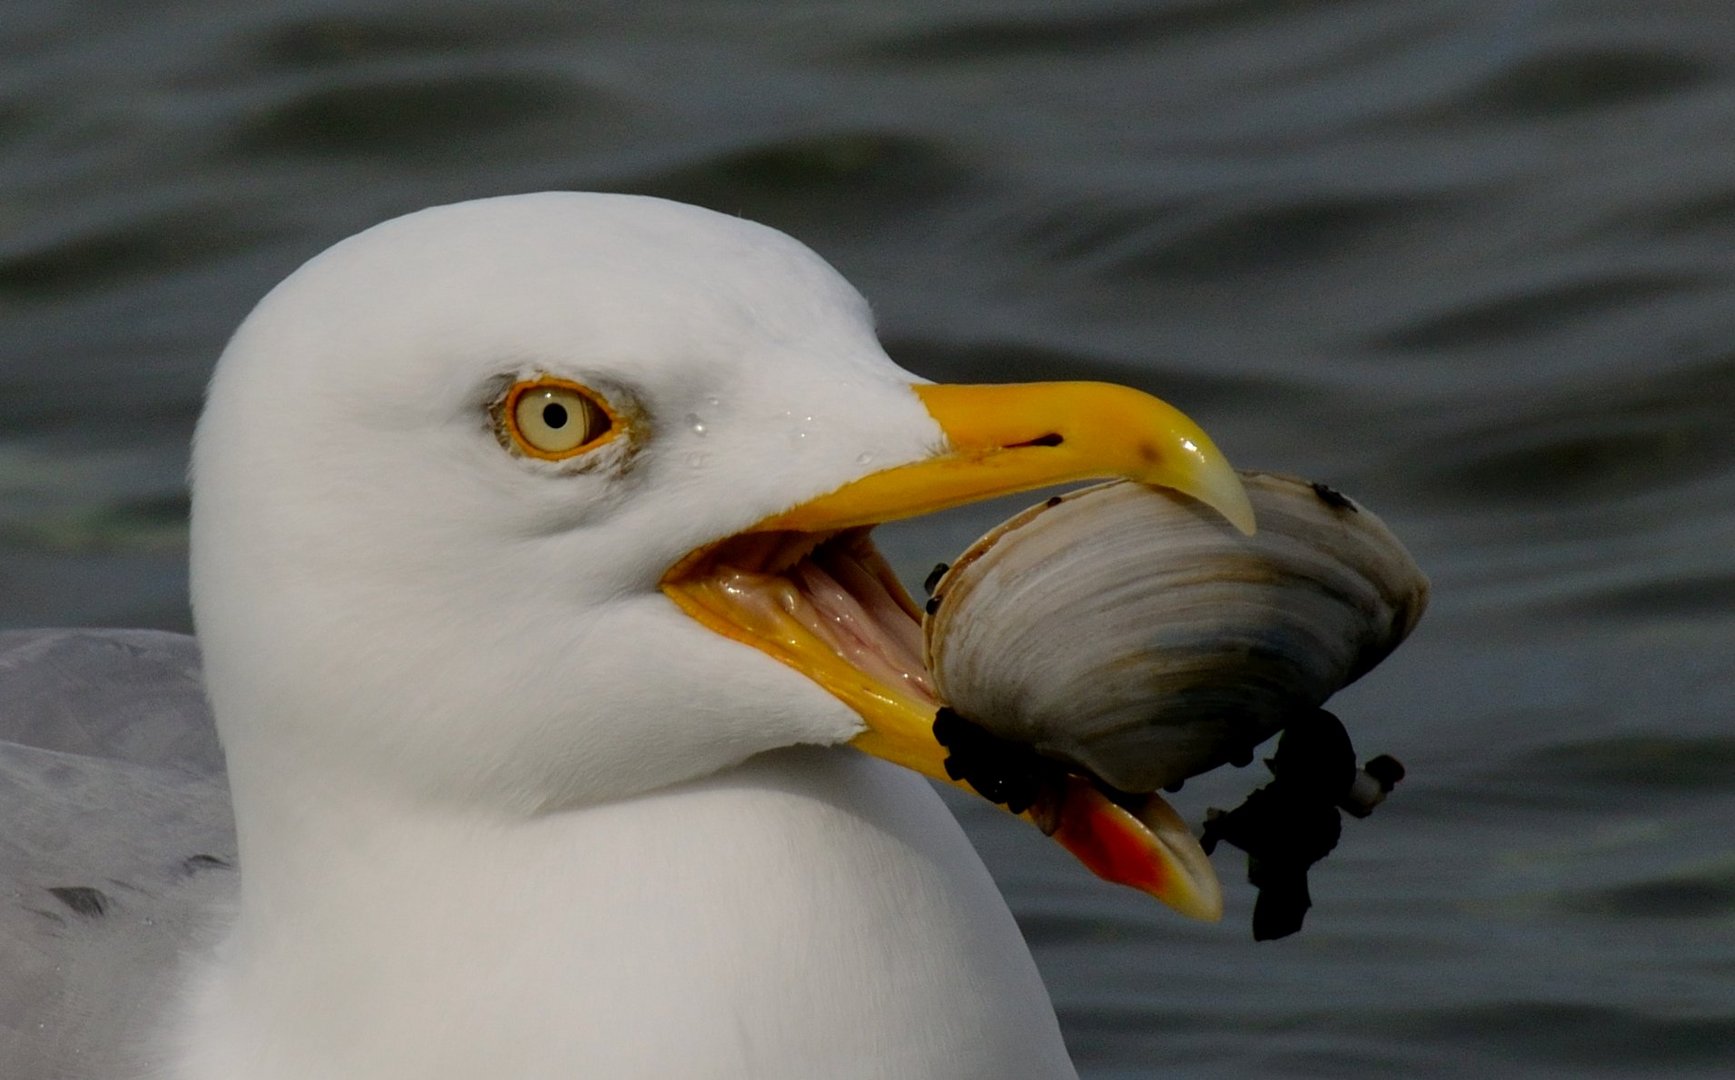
[193,193,1251,906]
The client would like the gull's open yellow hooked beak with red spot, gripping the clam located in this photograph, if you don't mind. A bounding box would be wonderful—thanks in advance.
[663,382,1253,919]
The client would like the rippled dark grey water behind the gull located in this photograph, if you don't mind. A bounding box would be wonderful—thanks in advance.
[0,0,1735,1080]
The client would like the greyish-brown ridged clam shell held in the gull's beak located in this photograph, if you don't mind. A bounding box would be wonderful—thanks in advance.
[923,472,1428,792]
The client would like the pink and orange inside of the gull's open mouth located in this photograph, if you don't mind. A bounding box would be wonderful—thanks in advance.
[663,528,939,717]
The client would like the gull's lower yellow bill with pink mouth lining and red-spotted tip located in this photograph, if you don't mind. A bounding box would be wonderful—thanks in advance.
[663,526,1221,920]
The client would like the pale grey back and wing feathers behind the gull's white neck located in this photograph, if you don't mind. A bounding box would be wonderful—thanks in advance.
[0,630,236,1080]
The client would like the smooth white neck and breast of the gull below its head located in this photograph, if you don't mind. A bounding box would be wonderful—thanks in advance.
[169,748,1074,1080]
